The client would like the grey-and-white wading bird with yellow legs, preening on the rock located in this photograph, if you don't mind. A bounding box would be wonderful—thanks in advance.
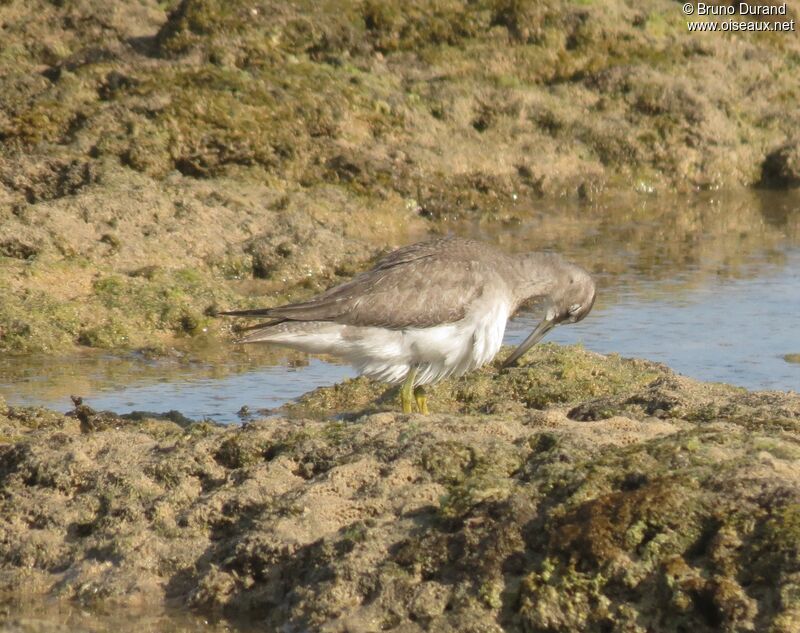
[220,236,596,415]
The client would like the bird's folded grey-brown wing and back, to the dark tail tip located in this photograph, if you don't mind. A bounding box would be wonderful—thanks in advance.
[222,239,501,329]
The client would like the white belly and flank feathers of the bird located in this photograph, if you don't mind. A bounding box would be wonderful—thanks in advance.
[247,301,510,385]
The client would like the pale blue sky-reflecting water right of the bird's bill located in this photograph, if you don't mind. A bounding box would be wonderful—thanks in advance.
[506,249,800,390]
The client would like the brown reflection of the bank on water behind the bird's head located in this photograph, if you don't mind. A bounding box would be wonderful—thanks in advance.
[450,190,800,282]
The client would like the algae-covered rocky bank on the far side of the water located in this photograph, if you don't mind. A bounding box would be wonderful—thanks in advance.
[0,0,800,353]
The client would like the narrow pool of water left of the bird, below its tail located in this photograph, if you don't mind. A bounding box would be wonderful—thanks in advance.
[0,343,353,422]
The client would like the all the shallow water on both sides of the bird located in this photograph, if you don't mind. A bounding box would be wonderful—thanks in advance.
[0,191,800,422]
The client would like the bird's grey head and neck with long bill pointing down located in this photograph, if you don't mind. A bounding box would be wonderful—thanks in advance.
[503,254,596,367]
